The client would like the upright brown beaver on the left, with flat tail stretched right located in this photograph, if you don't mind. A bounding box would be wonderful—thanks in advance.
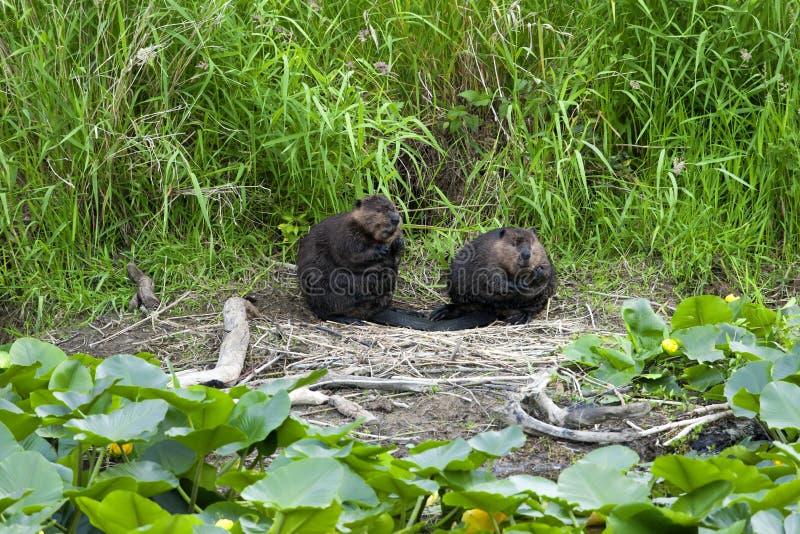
[296,195,494,330]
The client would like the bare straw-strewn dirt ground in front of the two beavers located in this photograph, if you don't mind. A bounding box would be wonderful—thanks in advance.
[44,264,754,478]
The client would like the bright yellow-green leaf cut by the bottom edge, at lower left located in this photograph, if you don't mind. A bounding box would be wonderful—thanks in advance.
[75,490,170,534]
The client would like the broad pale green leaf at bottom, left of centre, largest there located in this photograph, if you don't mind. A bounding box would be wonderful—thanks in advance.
[242,458,344,517]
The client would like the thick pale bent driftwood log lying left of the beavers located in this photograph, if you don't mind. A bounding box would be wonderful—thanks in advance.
[176,297,259,386]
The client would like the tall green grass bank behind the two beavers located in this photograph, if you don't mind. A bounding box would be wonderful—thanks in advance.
[0,0,800,328]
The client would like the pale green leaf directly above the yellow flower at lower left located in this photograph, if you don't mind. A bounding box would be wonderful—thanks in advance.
[64,399,169,445]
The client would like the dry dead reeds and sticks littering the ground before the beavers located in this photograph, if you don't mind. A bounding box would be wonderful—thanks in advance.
[40,264,748,474]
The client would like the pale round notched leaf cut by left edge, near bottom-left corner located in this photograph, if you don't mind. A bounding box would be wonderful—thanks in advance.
[0,451,64,516]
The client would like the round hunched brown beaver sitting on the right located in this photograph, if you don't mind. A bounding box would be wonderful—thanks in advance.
[431,228,556,323]
